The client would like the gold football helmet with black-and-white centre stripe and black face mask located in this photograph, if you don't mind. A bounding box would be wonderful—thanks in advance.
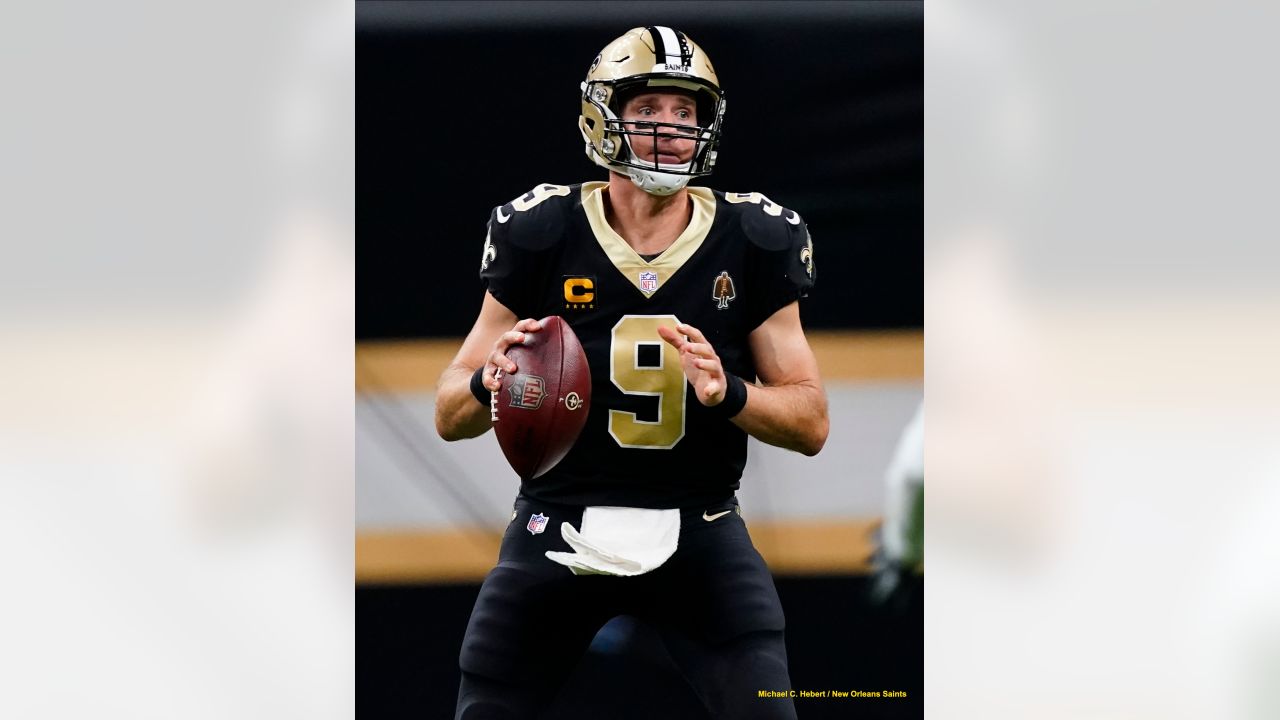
[577,26,724,195]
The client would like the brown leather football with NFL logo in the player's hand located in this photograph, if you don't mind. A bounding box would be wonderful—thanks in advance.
[492,315,591,479]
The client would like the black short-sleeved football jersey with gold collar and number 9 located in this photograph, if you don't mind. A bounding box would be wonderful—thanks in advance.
[480,182,814,507]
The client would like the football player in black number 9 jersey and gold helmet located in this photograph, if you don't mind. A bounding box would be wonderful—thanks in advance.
[435,27,828,719]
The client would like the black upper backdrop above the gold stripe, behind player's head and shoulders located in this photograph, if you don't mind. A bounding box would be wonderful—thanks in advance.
[356,1,923,340]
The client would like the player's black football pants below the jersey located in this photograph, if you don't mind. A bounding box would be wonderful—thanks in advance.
[456,496,795,720]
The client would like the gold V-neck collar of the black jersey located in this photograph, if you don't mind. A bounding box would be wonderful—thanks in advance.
[582,182,716,295]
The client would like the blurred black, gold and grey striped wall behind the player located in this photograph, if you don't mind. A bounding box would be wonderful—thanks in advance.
[356,1,923,717]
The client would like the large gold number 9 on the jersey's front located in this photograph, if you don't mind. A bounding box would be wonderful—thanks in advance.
[609,315,689,450]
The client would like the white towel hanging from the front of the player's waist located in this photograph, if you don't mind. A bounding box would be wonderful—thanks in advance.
[547,507,680,575]
